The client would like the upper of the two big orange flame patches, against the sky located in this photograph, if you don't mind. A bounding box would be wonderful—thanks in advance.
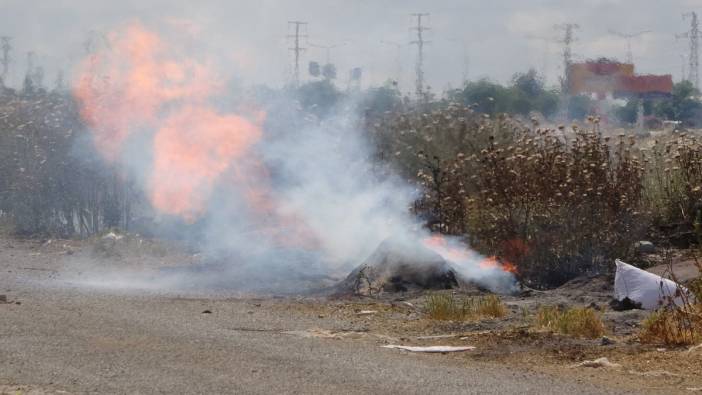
[74,24,215,161]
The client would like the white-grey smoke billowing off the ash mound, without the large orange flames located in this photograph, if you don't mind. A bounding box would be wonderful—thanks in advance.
[66,21,514,291]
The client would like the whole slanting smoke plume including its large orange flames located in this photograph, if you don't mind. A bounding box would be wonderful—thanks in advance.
[74,23,514,290]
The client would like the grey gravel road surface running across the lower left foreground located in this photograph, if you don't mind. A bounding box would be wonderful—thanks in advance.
[0,240,640,394]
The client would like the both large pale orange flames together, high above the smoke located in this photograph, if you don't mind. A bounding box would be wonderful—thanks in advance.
[74,23,263,221]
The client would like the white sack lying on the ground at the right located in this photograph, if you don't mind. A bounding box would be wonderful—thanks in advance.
[614,259,689,310]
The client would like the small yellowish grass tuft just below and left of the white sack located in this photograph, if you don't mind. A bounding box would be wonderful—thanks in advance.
[536,306,605,339]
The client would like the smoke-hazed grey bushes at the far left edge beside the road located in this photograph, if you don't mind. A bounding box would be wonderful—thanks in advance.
[0,86,130,237]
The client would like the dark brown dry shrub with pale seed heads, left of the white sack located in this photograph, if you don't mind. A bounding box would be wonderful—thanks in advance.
[468,125,646,287]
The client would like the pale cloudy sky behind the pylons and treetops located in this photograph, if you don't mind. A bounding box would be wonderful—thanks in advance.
[0,0,702,92]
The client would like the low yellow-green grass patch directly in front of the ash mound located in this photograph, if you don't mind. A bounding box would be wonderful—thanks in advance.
[425,294,507,321]
